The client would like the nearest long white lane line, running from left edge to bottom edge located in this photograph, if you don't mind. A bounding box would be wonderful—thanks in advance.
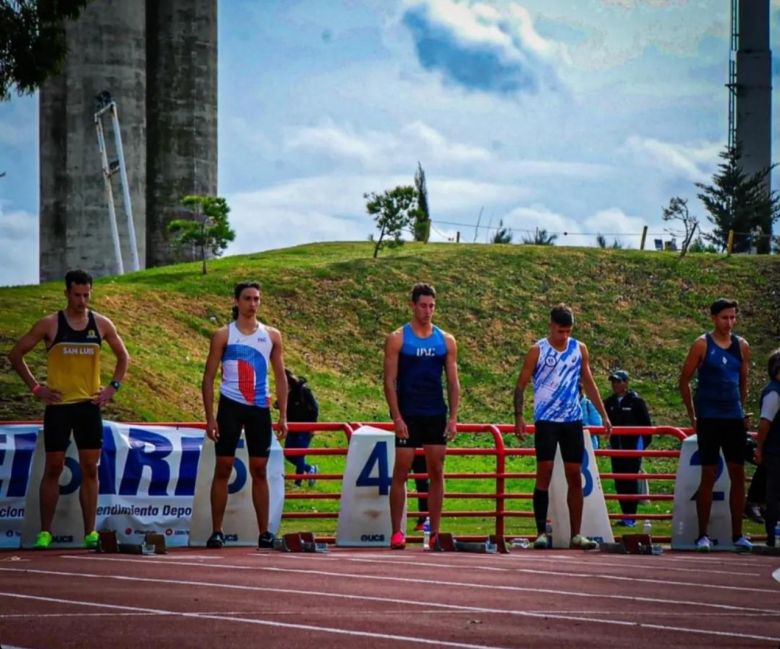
[0,592,501,649]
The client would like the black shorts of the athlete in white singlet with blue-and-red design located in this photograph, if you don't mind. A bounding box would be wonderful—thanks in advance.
[214,395,273,457]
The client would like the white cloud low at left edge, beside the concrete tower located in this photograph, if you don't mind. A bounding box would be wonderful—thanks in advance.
[0,206,38,286]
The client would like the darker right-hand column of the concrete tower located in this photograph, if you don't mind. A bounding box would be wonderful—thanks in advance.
[146,0,217,267]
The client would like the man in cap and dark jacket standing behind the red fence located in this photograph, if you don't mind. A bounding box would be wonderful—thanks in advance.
[604,370,653,527]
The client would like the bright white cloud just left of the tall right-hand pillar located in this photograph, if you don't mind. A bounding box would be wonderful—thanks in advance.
[623,135,721,182]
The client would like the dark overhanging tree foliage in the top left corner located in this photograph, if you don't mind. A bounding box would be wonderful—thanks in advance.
[0,0,89,101]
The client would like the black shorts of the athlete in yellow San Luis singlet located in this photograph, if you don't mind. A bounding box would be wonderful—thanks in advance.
[43,401,103,453]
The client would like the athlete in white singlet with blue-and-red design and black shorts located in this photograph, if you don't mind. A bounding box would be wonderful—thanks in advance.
[202,282,287,548]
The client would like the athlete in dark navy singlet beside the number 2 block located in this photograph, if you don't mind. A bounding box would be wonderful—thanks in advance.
[679,298,752,552]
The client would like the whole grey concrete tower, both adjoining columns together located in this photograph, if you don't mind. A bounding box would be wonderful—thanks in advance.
[40,0,217,281]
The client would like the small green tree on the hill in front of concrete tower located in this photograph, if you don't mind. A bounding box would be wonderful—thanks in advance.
[168,195,236,275]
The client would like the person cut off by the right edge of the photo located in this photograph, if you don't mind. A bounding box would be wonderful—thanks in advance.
[756,349,780,548]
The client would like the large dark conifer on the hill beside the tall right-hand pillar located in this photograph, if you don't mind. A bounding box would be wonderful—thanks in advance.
[696,146,780,254]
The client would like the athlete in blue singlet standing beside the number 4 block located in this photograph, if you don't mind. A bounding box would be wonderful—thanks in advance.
[384,284,460,550]
